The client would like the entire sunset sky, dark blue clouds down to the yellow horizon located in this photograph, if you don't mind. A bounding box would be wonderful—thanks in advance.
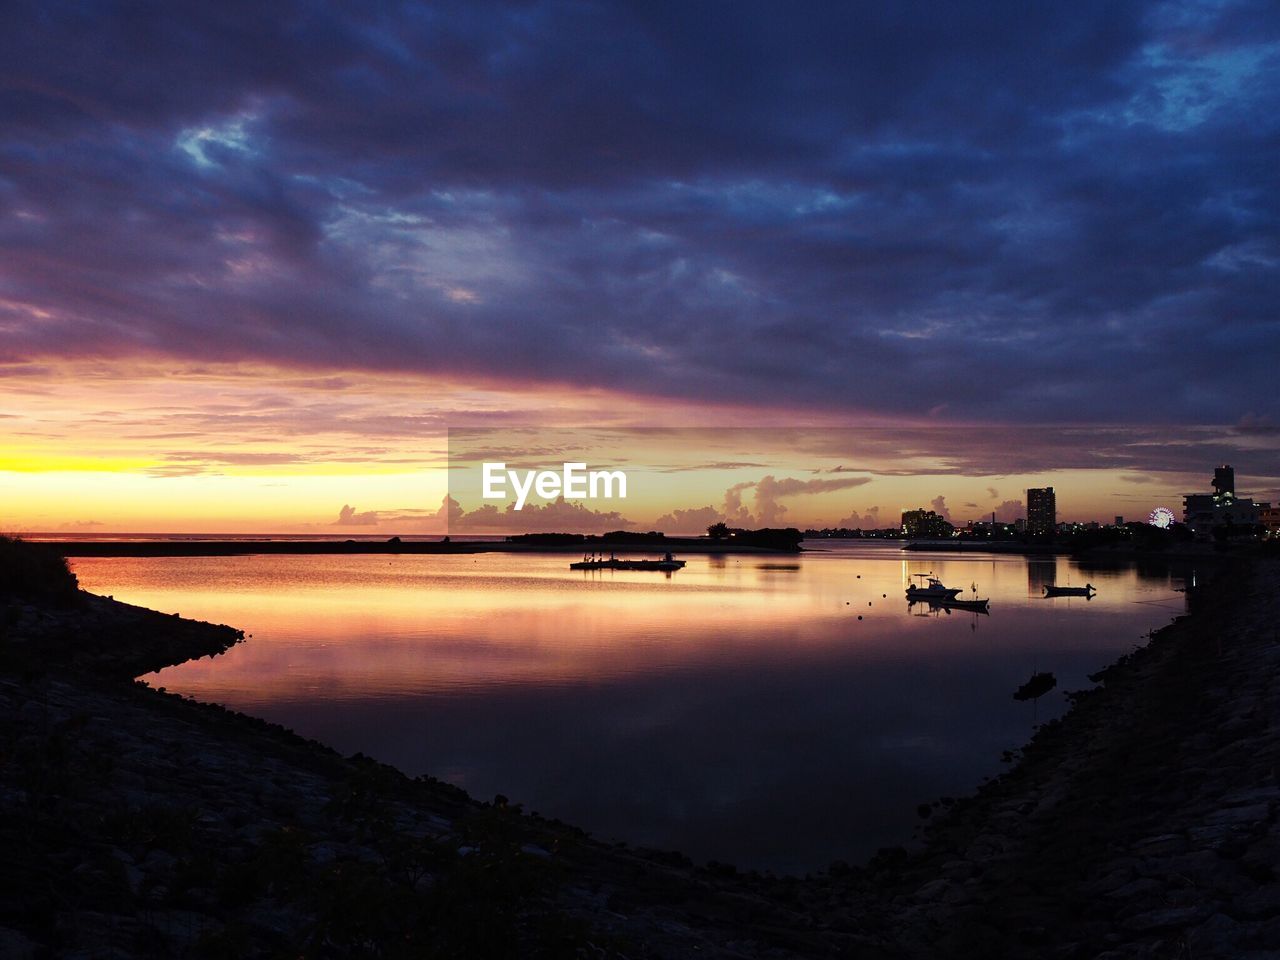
[0,1,1280,531]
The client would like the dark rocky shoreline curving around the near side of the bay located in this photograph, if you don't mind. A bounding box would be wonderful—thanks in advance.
[0,561,1280,960]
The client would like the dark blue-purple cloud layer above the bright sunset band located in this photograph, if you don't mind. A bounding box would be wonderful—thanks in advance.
[0,3,1280,422]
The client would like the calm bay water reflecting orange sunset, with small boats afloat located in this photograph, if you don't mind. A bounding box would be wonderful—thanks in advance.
[74,543,1183,872]
